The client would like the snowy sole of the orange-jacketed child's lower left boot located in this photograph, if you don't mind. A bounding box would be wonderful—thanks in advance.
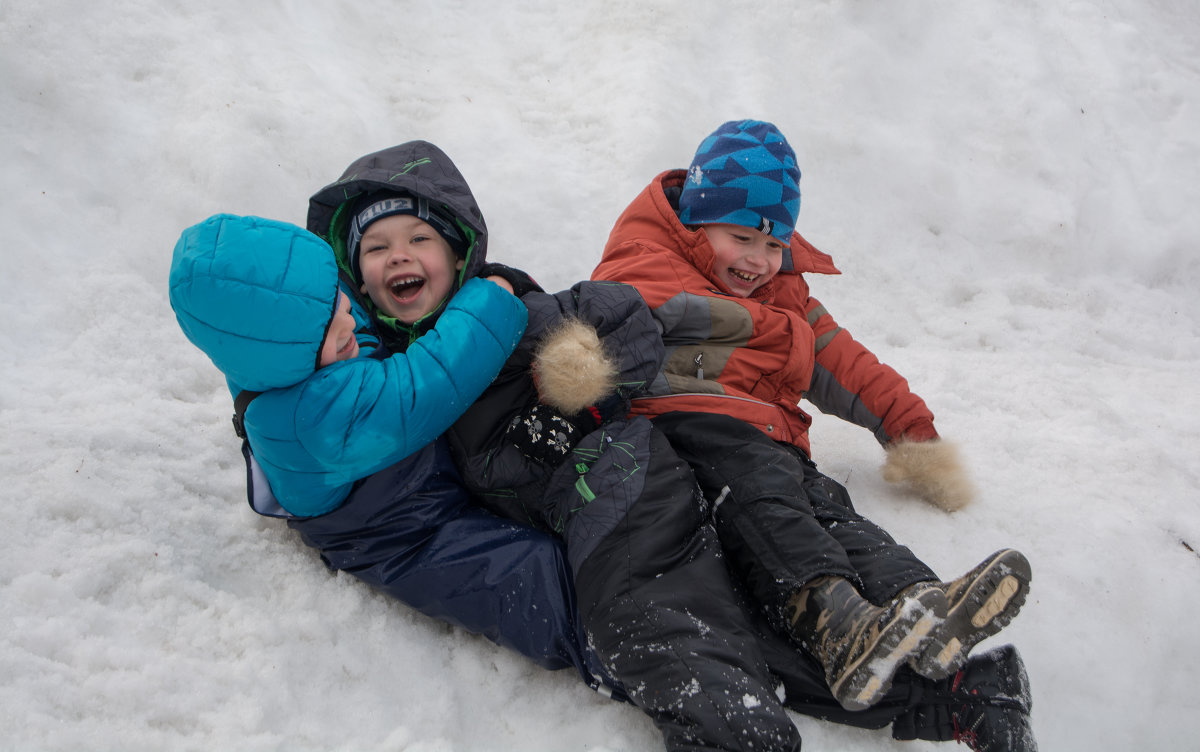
[829,588,944,710]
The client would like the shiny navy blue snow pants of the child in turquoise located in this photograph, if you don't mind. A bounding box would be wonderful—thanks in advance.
[288,439,611,687]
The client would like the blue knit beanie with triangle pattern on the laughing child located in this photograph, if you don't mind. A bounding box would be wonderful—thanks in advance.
[679,120,800,245]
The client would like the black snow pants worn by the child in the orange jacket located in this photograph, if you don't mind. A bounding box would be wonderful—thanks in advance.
[654,413,937,619]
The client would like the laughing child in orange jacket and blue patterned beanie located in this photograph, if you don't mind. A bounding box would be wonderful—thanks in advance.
[592,120,1031,724]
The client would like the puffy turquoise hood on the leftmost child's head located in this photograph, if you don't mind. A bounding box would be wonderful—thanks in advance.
[169,215,338,395]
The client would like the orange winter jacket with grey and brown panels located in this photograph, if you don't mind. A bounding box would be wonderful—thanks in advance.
[592,170,937,453]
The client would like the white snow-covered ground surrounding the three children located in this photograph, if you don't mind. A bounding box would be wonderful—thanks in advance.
[0,0,1200,752]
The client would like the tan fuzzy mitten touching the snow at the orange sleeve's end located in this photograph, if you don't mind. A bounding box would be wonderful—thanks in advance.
[883,439,974,512]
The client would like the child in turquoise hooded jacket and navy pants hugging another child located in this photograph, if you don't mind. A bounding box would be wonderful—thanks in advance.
[169,215,614,686]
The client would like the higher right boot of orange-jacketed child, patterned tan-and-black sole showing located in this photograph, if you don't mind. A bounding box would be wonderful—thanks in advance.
[901,548,1032,679]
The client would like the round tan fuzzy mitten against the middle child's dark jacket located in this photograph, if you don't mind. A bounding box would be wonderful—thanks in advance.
[533,319,617,415]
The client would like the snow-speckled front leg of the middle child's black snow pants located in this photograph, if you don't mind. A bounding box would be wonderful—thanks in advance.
[551,417,800,751]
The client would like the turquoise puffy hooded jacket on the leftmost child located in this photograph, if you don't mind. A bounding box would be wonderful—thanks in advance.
[169,215,526,517]
